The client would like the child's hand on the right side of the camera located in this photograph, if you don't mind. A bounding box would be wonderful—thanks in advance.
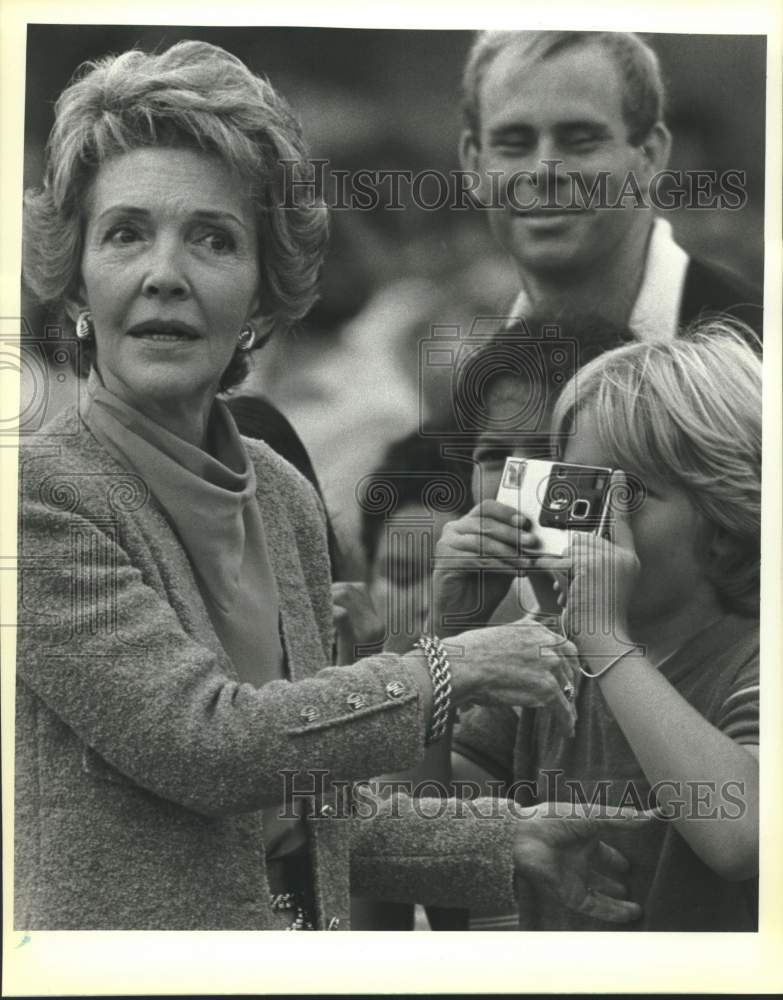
[555,472,640,650]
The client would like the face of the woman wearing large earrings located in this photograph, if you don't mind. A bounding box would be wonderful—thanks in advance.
[78,148,260,419]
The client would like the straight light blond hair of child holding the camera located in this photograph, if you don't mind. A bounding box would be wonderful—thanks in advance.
[553,319,761,617]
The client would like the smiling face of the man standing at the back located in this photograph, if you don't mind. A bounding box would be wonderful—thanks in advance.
[463,45,662,274]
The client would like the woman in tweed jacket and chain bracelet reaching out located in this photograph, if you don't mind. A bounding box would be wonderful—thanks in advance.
[15,42,636,929]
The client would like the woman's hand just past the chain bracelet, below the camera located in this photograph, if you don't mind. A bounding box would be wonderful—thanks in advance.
[444,619,578,736]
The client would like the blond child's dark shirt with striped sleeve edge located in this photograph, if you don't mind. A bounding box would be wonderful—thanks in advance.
[453,615,759,931]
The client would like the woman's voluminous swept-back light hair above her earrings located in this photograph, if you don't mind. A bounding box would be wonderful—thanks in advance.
[23,41,327,386]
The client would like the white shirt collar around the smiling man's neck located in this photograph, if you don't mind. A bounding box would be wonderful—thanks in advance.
[511,218,689,340]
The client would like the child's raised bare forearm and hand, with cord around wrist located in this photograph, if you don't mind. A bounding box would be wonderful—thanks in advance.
[565,500,758,880]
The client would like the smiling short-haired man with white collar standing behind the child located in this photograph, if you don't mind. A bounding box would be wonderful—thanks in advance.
[460,31,761,339]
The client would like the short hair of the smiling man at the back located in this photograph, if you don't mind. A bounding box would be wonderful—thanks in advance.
[462,31,664,145]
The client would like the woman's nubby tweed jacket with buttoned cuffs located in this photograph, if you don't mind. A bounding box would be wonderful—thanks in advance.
[14,408,515,930]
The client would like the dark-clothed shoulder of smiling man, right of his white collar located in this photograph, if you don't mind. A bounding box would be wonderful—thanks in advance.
[680,257,764,337]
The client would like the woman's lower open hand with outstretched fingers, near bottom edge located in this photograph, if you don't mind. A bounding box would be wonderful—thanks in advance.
[514,802,651,924]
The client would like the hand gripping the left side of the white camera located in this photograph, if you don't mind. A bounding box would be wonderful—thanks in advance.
[431,500,539,636]
